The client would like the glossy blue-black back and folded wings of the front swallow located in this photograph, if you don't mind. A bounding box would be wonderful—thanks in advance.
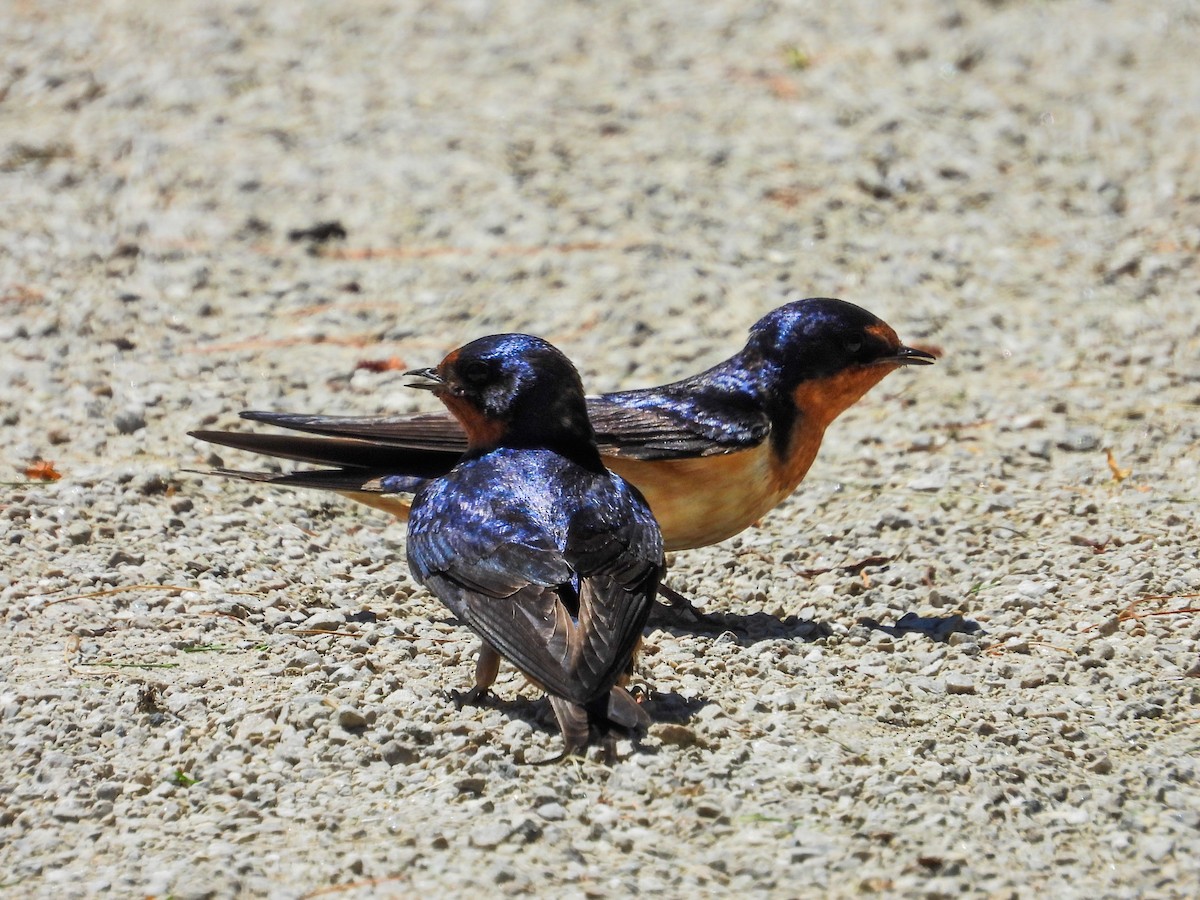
[408,454,662,704]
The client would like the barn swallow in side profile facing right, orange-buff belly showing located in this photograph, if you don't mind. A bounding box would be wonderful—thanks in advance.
[191,298,935,549]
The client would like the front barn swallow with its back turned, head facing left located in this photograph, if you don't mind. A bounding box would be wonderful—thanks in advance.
[407,335,664,758]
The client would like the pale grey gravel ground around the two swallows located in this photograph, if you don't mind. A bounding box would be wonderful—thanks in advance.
[0,0,1200,898]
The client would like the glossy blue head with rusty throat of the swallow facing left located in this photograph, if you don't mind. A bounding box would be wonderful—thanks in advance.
[408,334,595,451]
